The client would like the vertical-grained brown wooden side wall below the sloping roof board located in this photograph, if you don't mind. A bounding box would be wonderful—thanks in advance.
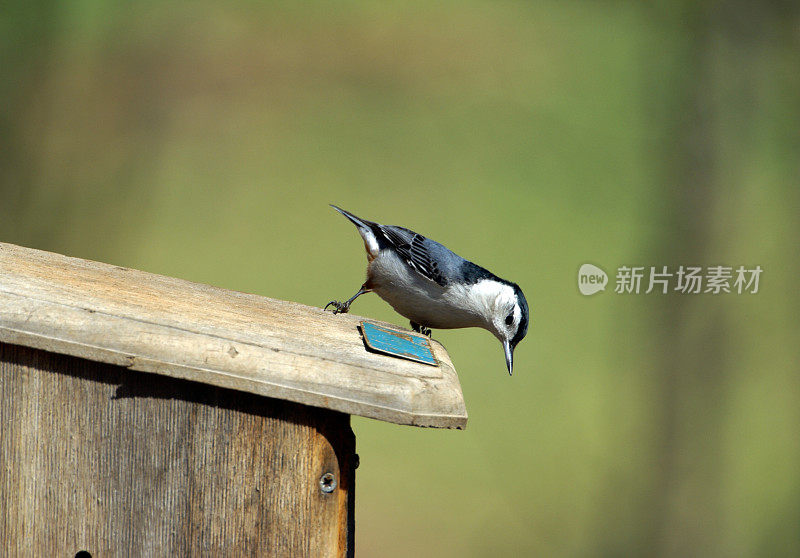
[0,343,357,557]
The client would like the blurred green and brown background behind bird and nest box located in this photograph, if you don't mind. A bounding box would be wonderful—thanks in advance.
[0,0,800,558]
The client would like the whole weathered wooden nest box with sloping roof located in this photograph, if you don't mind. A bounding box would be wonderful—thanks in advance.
[0,243,467,557]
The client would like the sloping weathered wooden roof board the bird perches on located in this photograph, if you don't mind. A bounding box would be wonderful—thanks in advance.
[0,243,467,428]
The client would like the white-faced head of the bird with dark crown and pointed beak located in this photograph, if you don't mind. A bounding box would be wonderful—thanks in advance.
[478,279,528,375]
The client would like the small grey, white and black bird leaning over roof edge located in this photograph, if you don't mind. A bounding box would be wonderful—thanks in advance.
[323,204,529,375]
